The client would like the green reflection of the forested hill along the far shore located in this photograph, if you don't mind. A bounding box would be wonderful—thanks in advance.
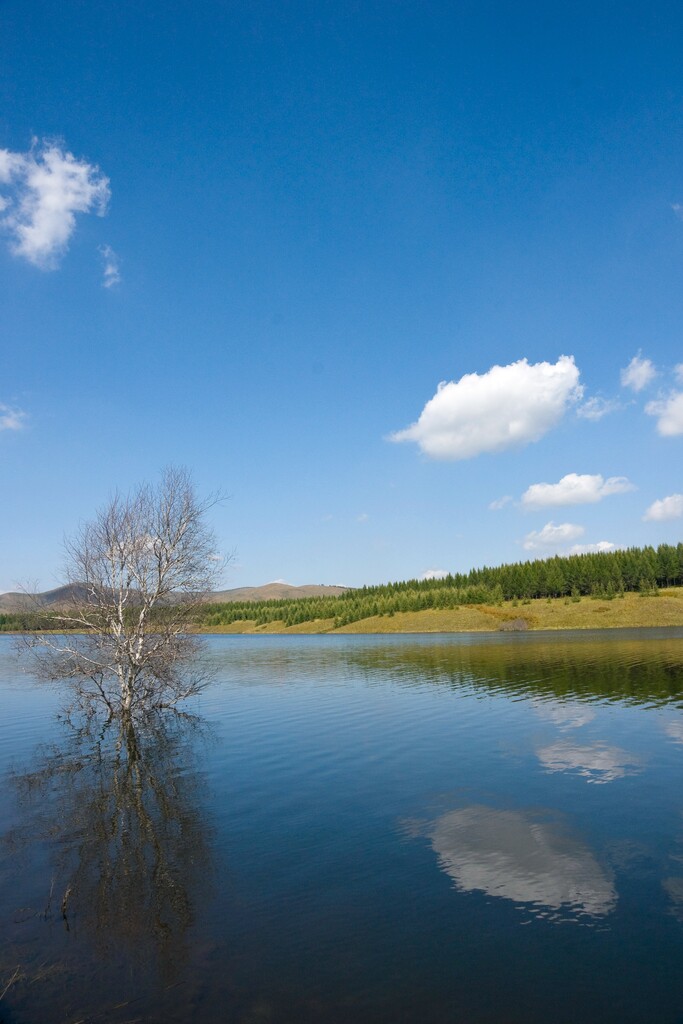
[201,628,683,715]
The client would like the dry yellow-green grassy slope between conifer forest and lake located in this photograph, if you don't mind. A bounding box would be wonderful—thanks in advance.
[198,588,683,634]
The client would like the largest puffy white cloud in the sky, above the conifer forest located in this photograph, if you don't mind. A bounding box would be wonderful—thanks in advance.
[390,355,583,460]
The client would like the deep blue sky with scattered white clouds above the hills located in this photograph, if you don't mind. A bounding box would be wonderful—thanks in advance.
[0,0,683,590]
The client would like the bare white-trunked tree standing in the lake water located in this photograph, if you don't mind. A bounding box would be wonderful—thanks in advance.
[28,468,222,717]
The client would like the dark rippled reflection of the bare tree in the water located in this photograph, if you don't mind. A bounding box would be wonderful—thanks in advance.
[7,712,211,1020]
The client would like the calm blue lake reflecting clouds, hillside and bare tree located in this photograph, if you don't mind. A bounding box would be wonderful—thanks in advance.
[0,629,683,1024]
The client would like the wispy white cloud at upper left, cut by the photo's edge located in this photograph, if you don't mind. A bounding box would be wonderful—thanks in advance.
[0,142,111,270]
